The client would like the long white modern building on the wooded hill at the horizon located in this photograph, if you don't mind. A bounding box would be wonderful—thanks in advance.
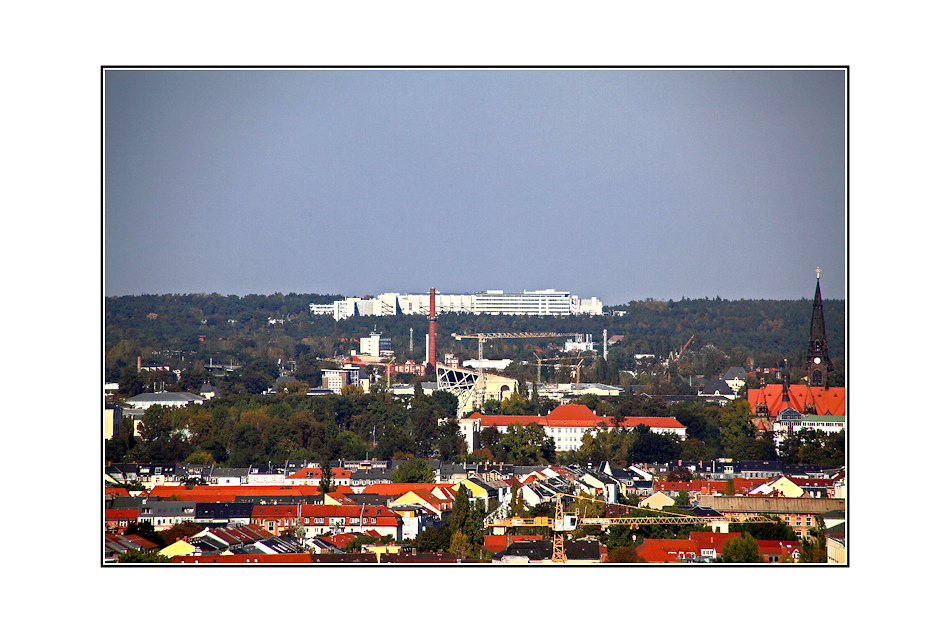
[310,289,604,321]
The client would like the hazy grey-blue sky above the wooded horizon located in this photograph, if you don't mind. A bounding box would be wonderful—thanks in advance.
[104,69,847,305]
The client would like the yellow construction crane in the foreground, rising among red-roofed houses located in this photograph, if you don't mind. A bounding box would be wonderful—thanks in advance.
[485,492,776,563]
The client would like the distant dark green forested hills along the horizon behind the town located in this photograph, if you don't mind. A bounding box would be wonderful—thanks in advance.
[104,293,845,384]
